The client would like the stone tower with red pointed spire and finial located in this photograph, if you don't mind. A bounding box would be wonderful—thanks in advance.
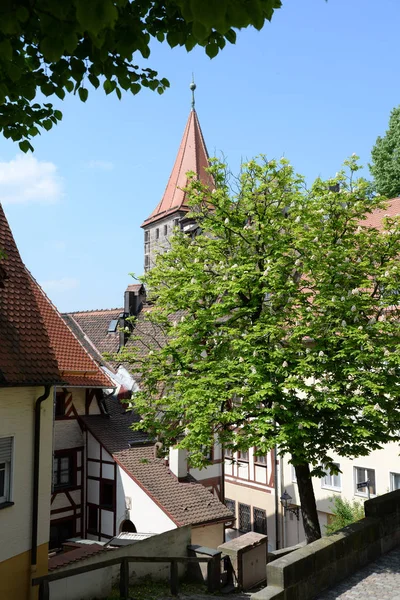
[141,82,214,271]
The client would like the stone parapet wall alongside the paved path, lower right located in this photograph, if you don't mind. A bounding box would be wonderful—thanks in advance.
[252,490,400,600]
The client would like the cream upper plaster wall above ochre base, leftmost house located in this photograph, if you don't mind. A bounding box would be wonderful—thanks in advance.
[0,386,53,562]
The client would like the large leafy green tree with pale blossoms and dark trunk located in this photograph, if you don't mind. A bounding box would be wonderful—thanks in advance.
[120,158,400,541]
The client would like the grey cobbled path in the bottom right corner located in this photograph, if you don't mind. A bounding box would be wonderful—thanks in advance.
[317,548,400,600]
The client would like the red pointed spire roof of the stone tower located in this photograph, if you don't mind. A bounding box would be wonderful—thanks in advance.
[142,109,214,227]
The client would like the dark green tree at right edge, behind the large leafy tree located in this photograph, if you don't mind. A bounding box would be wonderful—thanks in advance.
[369,106,400,198]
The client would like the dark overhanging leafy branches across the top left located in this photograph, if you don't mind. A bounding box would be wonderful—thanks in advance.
[0,0,281,152]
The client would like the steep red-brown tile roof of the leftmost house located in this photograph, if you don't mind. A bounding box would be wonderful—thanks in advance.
[0,206,113,388]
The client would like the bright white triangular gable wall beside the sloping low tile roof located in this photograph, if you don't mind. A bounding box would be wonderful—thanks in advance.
[117,466,176,533]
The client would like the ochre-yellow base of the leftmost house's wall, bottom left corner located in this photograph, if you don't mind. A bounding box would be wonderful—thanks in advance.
[0,544,48,600]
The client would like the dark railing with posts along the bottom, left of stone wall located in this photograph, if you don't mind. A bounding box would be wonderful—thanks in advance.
[32,553,221,600]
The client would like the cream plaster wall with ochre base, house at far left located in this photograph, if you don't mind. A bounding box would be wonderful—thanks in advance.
[0,386,53,600]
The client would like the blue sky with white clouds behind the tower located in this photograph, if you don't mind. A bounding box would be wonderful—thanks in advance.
[0,0,400,311]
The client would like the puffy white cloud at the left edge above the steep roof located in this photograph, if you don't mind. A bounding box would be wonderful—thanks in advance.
[0,154,63,204]
